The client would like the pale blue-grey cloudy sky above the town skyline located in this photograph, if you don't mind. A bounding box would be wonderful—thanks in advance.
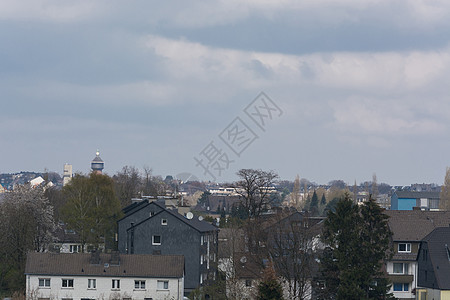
[0,0,450,185]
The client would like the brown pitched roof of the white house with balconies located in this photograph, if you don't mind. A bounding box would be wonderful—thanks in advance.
[385,210,450,242]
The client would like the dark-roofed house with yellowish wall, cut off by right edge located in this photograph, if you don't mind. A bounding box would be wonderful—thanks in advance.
[416,226,450,300]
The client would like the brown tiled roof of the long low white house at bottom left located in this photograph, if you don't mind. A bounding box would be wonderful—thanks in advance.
[25,252,184,278]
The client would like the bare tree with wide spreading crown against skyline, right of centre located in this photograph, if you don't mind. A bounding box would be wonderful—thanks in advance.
[235,169,278,218]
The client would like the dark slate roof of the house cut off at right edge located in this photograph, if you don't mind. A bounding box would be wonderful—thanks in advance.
[423,227,450,290]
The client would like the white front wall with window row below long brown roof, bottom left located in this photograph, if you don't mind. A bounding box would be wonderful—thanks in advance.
[26,275,184,300]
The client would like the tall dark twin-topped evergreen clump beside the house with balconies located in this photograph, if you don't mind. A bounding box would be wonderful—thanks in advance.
[321,194,392,300]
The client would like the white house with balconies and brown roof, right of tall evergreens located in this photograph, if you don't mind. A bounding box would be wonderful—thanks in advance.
[385,209,450,299]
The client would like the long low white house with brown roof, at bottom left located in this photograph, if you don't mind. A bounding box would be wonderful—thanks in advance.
[25,252,184,300]
